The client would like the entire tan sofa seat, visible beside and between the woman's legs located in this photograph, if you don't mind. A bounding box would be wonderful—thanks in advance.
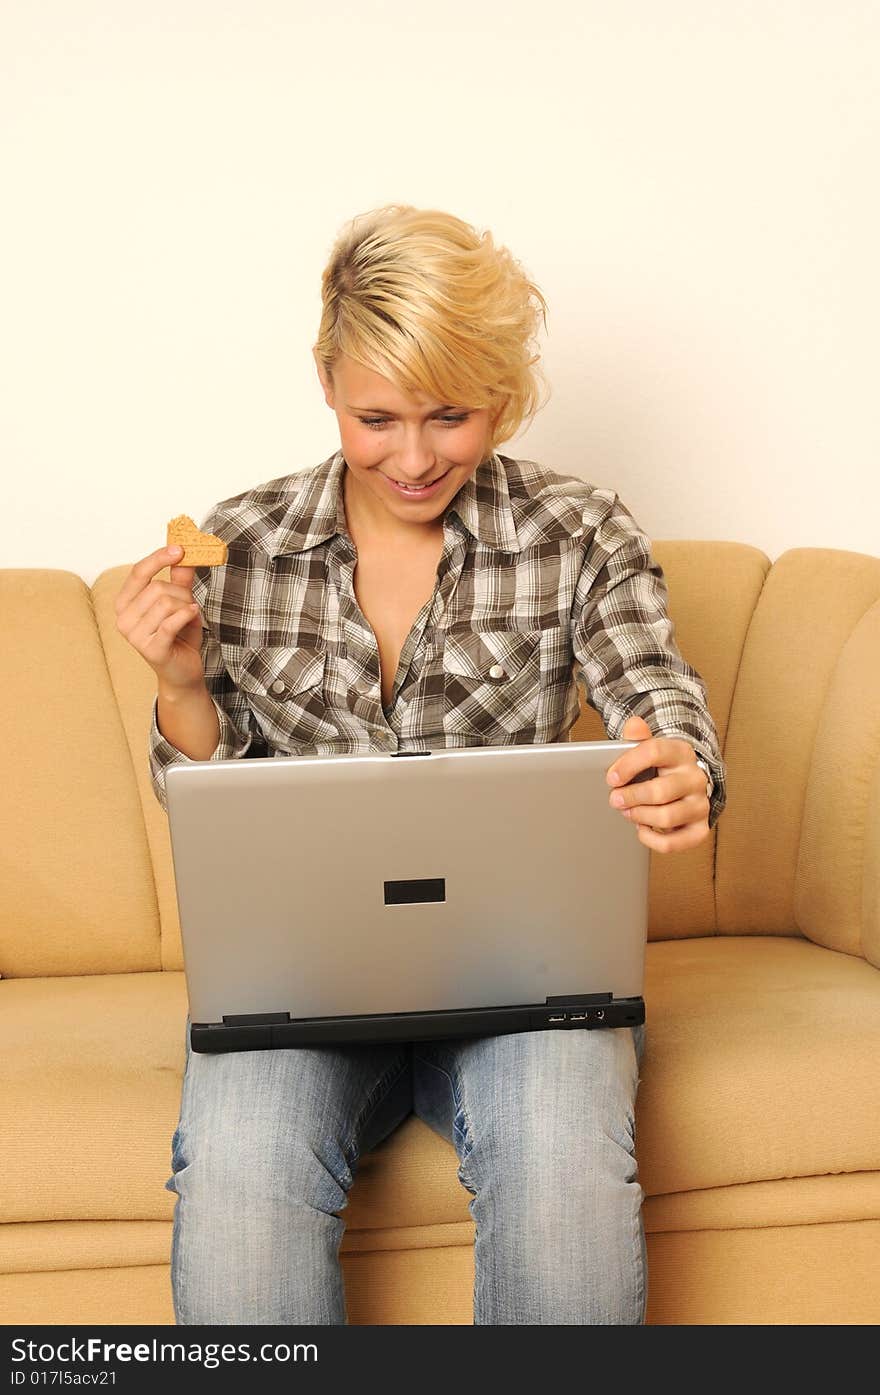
[0,936,880,1233]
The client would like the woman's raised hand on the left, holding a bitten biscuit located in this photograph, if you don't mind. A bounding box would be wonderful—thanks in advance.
[116,547,205,691]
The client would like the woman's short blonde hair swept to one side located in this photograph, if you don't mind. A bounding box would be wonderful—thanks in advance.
[315,204,549,453]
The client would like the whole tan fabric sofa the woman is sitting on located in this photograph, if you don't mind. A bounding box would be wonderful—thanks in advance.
[0,541,880,1324]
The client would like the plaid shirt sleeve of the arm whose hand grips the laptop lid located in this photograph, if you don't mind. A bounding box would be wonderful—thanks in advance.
[572,491,727,829]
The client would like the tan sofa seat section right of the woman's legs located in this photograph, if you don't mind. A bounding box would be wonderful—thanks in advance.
[636,936,880,1196]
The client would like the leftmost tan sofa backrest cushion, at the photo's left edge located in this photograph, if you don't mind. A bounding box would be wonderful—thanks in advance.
[0,568,160,978]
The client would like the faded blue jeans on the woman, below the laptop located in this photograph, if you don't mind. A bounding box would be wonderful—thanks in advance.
[165,1017,647,1325]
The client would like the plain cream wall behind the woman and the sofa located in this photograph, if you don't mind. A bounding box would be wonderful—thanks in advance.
[0,0,880,582]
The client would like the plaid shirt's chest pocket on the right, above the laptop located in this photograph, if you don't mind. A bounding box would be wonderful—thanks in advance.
[441,629,545,745]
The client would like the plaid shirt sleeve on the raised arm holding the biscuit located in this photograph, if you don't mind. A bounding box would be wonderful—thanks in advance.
[149,560,269,813]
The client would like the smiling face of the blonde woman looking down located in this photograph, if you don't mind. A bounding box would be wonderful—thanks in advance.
[312,350,491,537]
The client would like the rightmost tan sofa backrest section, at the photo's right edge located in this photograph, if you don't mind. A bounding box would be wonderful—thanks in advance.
[715,548,880,963]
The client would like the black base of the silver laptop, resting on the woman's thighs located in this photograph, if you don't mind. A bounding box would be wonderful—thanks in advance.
[190,993,644,1053]
